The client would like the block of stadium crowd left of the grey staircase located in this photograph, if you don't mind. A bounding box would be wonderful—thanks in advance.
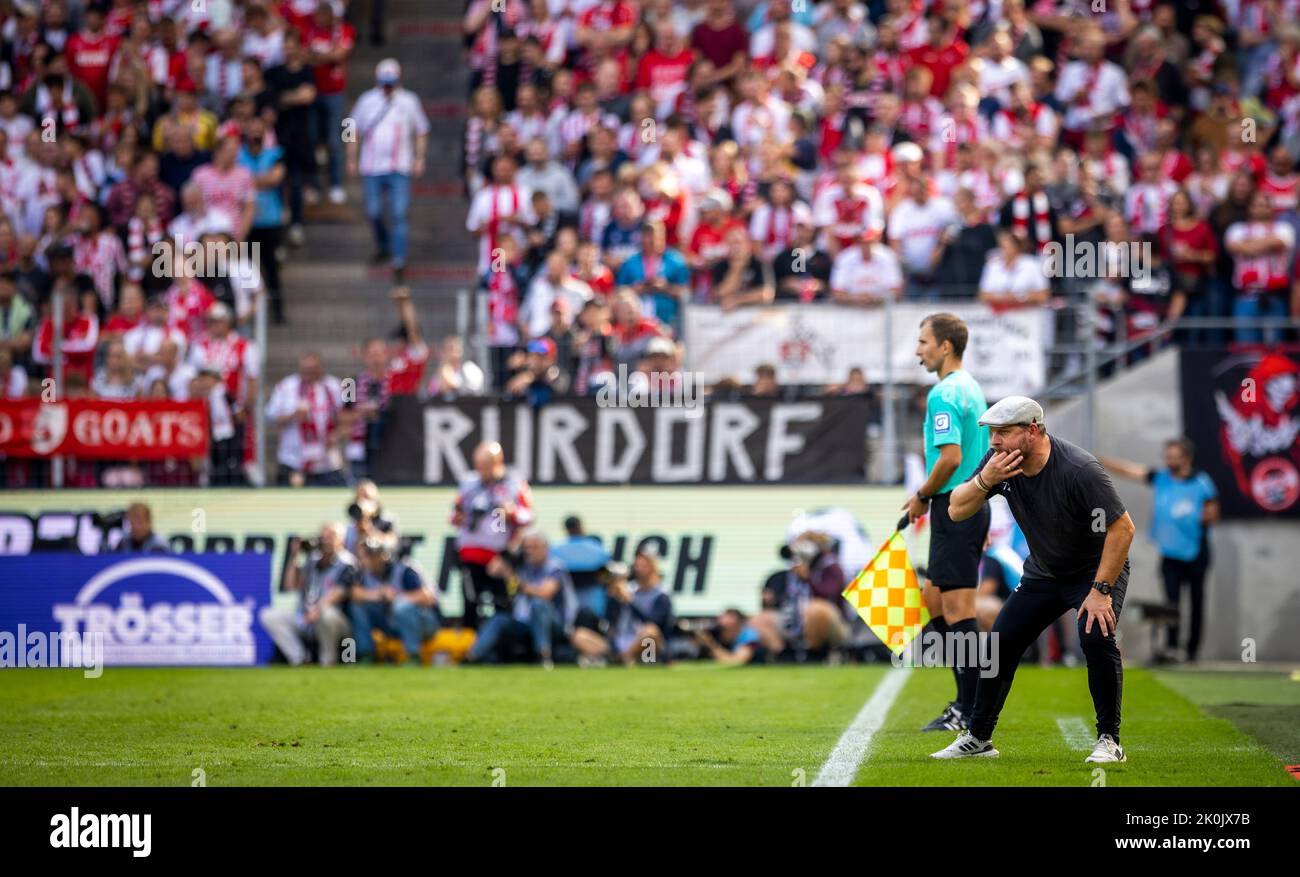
[0,0,382,487]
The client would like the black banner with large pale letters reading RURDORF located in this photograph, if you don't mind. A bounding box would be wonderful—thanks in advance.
[372,396,868,485]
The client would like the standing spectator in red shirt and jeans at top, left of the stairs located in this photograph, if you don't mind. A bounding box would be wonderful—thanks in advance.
[302,3,356,204]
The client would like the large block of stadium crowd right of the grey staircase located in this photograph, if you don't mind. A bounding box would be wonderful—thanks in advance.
[449,0,1300,407]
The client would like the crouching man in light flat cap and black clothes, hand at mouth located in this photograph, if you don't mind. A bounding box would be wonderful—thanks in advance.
[932,396,1135,761]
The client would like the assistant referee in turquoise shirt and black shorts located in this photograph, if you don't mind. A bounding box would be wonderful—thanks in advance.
[902,313,989,730]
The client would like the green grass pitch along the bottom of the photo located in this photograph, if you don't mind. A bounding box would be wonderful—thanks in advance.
[0,665,1300,786]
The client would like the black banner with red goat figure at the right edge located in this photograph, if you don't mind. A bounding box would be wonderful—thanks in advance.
[1179,350,1300,517]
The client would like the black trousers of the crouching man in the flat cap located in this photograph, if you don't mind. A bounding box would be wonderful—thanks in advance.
[970,563,1128,741]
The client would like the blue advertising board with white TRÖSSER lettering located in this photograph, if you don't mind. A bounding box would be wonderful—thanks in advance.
[0,552,272,667]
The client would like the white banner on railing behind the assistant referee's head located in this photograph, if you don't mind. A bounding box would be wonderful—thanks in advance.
[685,303,1053,401]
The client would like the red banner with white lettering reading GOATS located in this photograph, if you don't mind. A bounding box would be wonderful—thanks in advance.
[0,399,208,460]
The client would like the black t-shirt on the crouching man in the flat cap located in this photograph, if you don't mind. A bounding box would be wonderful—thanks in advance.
[975,435,1125,581]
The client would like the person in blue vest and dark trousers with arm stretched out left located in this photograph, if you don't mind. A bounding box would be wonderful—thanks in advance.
[1101,438,1219,661]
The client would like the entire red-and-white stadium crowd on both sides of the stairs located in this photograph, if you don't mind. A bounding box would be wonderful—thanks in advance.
[0,0,1300,486]
